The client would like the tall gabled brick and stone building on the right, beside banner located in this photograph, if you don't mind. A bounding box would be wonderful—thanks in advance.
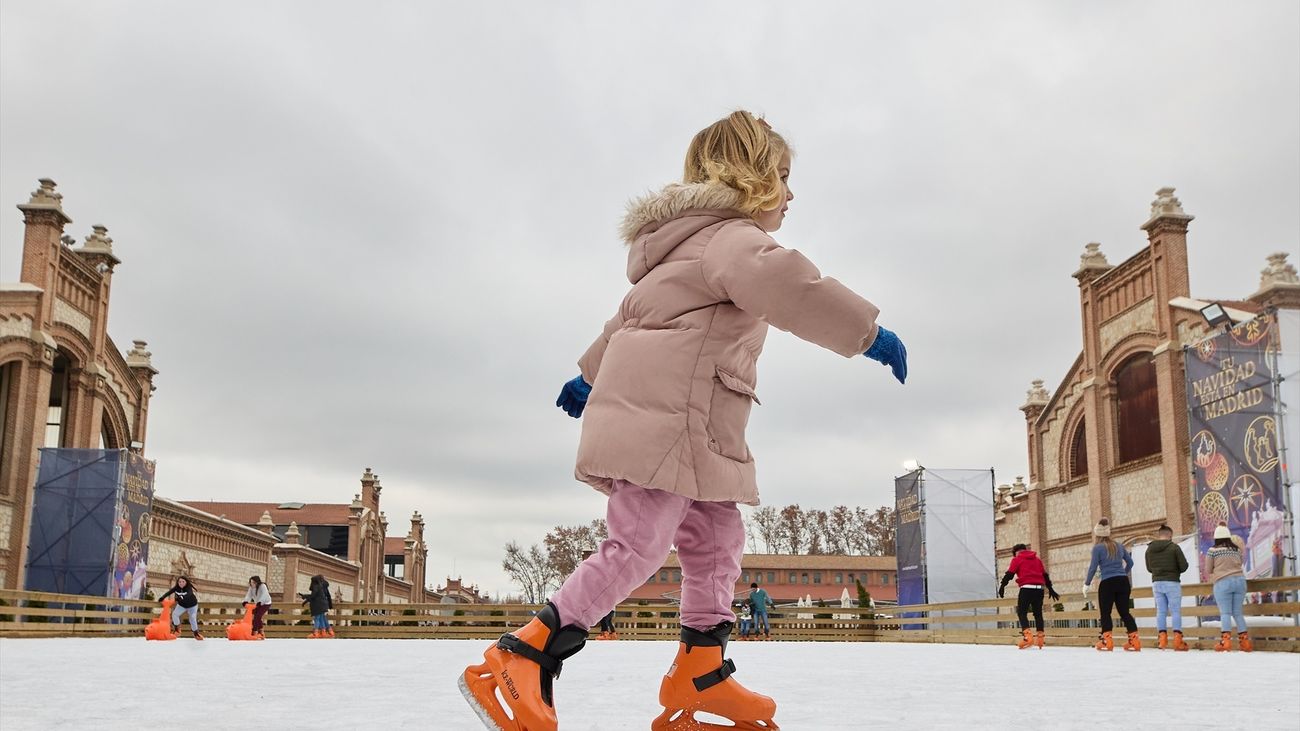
[995,189,1300,585]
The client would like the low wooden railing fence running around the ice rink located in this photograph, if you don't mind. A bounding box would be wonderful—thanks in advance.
[0,578,1300,652]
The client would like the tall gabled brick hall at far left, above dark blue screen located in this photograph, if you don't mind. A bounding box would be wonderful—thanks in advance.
[0,178,157,589]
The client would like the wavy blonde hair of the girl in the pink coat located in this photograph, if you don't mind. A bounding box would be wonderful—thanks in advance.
[681,109,790,216]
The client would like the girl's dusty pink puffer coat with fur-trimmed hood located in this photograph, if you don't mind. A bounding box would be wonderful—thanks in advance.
[576,183,879,505]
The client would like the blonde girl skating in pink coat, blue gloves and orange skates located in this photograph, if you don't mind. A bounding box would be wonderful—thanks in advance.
[460,112,907,731]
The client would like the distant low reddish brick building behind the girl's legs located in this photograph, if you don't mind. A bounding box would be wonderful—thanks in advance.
[628,552,898,604]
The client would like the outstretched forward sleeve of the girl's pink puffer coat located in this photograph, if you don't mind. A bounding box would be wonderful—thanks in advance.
[701,225,880,358]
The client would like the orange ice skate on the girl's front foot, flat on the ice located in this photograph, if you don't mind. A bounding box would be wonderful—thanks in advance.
[650,622,780,731]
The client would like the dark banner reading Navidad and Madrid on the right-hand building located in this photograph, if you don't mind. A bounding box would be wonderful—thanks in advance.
[1184,312,1286,581]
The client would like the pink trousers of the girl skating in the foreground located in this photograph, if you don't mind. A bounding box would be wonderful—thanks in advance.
[551,480,745,630]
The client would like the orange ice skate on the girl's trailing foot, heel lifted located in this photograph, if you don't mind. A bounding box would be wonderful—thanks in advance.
[459,604,586,731]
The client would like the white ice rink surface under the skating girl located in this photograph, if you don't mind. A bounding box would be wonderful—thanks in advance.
[0,639,1300,731]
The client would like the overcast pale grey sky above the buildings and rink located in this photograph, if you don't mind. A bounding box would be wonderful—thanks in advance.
[0,0,1300,592]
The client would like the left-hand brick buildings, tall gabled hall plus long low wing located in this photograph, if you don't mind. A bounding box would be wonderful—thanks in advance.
[0,179,473,602]
